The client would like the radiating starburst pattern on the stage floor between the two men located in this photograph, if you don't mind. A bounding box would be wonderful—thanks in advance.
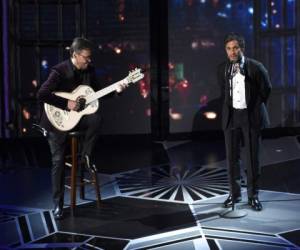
[116,165,229,203]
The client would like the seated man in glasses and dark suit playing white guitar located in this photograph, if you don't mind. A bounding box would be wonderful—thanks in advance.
[37,37,125,219]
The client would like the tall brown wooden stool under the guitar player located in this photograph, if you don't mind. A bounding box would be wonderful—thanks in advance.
[66,131,101,213]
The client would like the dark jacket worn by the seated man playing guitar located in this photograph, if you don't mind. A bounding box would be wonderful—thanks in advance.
[37,59,101,131]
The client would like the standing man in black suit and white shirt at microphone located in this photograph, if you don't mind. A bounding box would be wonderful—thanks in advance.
[217,33,272,211]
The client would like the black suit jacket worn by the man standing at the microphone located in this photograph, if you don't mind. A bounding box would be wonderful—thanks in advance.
[217,57,272,130]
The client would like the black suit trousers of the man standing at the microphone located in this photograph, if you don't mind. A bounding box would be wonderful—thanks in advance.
[224,110,261,198]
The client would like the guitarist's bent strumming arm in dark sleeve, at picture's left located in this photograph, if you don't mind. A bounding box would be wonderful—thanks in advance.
[37,69,72,110]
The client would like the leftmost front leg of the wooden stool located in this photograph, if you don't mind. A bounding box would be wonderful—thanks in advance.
[71,137,77,215]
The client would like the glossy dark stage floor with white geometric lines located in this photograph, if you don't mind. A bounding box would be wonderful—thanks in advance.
[0,136,300,249]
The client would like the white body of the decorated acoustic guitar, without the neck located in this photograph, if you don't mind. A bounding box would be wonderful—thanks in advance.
[44,85,99,131]
